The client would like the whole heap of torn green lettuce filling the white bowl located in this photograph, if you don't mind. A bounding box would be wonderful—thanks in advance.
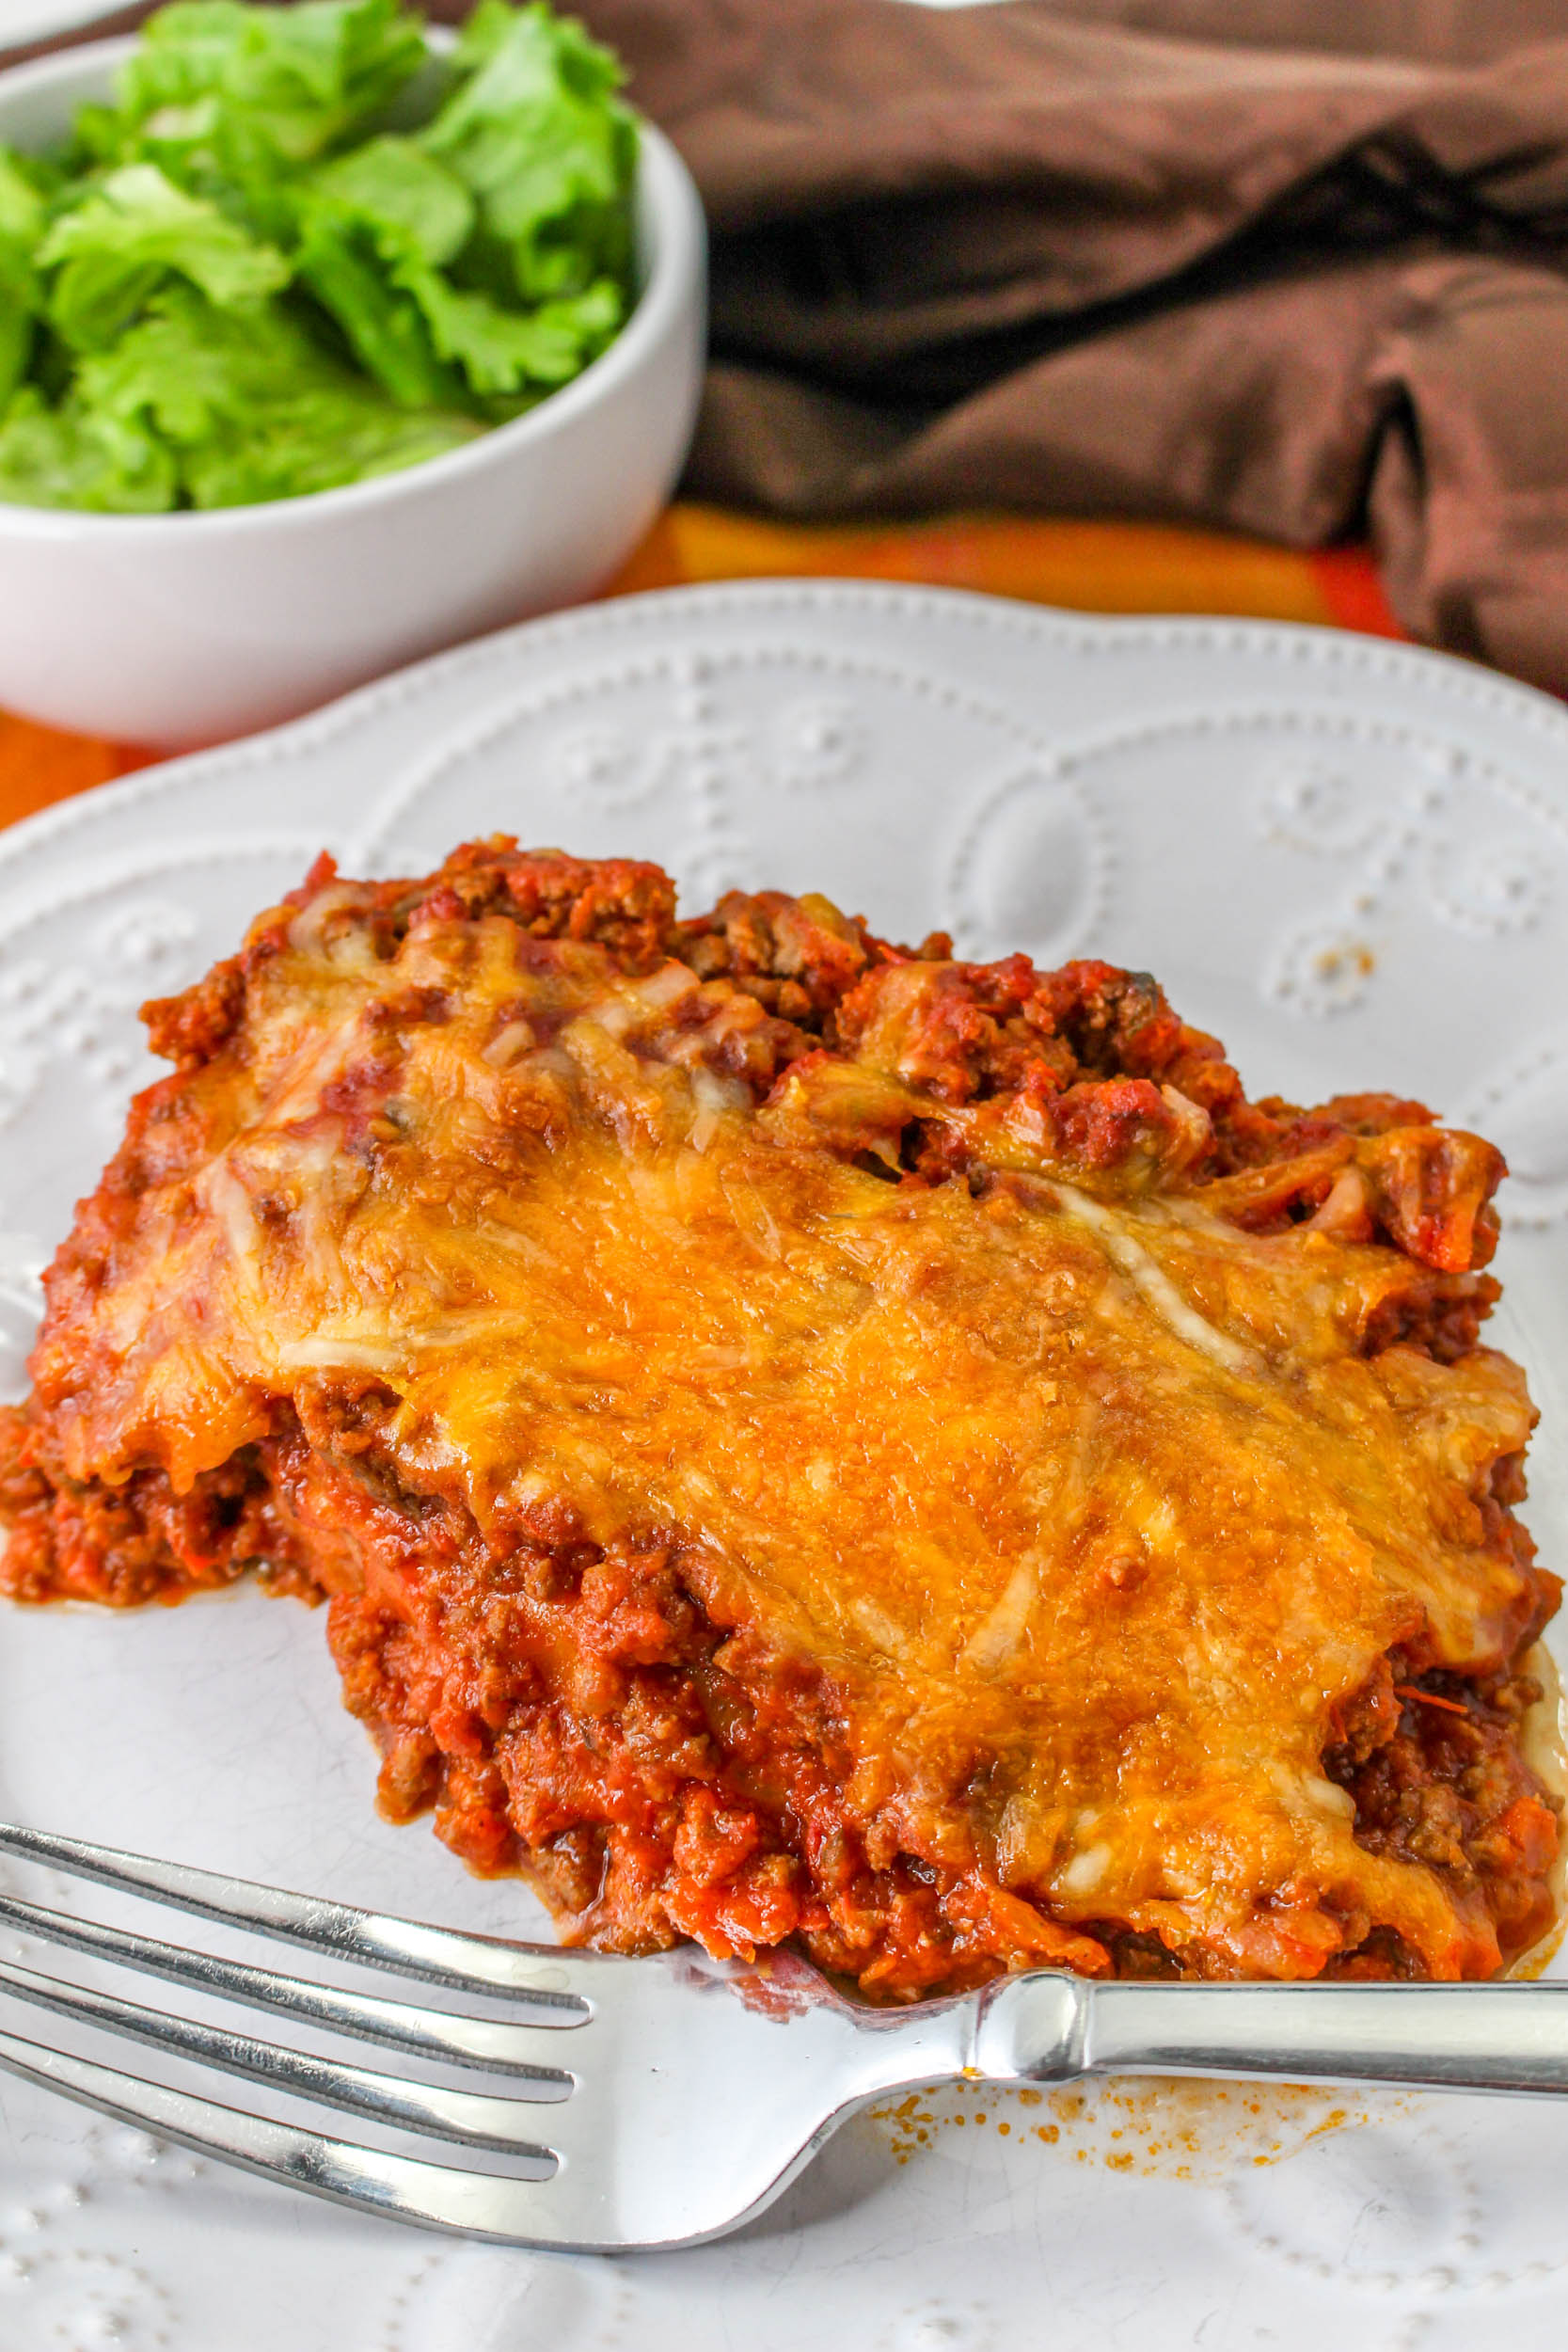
[0,0,637,513]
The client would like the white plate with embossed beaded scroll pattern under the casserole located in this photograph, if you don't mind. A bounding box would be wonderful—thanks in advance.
[0,583,1568,2352]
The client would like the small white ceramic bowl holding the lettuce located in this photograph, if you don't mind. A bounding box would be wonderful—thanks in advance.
[0,38,705,748]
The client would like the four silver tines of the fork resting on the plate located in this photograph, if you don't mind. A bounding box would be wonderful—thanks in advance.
[0,1825,623,2244]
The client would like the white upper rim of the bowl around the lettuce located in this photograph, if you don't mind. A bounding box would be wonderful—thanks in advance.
[0,26,707,544]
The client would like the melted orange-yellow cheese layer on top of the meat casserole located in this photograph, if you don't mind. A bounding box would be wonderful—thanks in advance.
[52,922,1530,1969]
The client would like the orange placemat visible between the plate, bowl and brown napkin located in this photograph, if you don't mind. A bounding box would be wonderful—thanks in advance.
[0,506,1402,823]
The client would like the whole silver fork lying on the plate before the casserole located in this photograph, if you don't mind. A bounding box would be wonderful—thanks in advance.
[0,1825,1568,2253]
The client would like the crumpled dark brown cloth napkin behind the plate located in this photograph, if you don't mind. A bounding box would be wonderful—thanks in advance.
[8,0,1568,691]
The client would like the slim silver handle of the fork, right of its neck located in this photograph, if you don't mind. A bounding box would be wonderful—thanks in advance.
[978,1976,1568,2093]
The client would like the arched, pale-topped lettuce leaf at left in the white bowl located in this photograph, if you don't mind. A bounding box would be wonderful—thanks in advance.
[38,163,292,351]
